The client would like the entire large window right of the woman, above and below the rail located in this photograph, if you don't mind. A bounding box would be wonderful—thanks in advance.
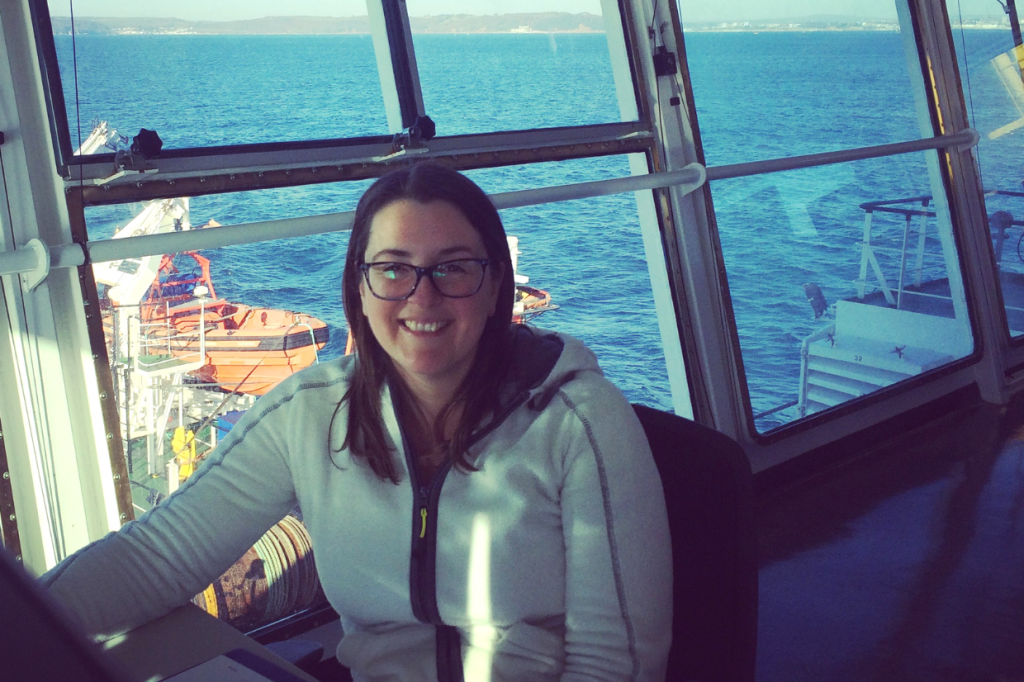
[678,0,973,432]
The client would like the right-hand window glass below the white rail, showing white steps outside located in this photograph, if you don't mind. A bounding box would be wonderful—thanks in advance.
[712,155,973,432]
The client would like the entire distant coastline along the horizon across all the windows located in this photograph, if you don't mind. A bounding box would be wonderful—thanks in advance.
[51,12,1010,36]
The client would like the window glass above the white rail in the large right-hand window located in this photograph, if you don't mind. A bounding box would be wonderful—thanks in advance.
[679,0,922,166]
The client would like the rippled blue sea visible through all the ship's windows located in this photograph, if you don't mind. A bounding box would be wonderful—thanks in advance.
[56,31,1024,430]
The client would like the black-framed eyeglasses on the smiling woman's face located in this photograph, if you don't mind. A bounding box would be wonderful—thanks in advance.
[359,258,490,301]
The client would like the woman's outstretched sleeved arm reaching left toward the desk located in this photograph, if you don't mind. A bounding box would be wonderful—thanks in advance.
[41,385,303,636]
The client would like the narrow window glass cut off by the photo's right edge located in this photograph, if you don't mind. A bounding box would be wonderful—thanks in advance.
[946,0,1024,337]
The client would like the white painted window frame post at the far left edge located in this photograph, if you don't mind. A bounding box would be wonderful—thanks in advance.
[0,1,121,572]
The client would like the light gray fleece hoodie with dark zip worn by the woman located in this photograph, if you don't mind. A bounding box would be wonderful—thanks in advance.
[43,327,672,682]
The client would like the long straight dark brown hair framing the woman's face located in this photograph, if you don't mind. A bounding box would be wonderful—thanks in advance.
[329,162,515,483]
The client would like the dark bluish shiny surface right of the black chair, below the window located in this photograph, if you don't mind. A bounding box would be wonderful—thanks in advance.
[757,391,1024,682]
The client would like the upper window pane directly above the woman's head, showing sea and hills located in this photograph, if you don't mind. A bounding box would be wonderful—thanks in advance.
[407,0,635,135]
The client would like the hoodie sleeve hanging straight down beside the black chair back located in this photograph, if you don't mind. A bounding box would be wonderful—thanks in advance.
[556,373,672,682]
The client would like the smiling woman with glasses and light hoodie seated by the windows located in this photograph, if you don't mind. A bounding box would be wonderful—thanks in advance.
[44,164,672,681]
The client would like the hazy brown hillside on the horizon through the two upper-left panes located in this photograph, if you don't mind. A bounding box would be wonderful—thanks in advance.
[51,12,604,36]
